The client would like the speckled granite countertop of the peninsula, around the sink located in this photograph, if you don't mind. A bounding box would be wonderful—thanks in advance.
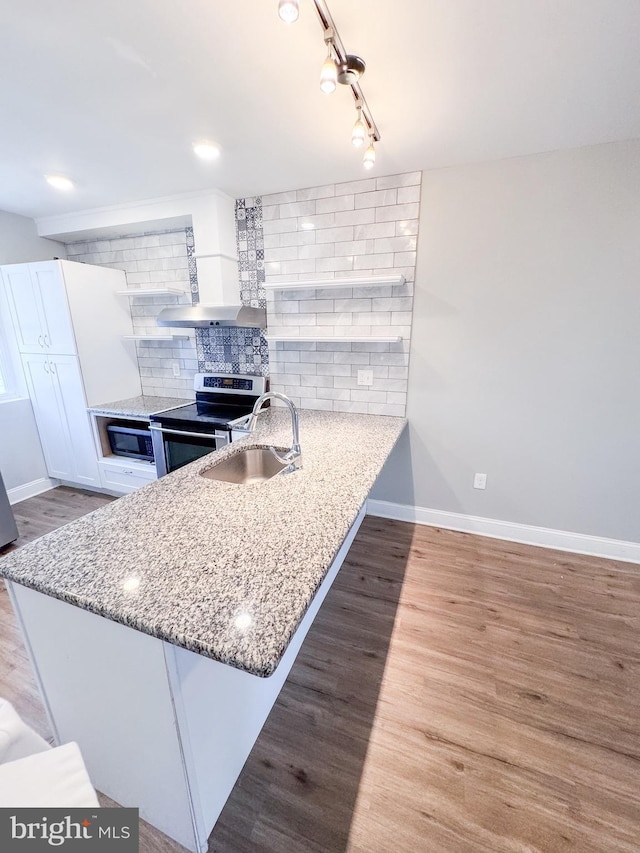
[0,407,406,676]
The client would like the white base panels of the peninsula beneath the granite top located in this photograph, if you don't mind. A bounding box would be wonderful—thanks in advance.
[7,507,365,853]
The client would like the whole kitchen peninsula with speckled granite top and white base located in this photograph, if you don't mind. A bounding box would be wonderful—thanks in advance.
[0,408,405,851]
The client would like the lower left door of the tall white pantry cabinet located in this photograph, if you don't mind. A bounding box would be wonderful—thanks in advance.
[22,354,73,480]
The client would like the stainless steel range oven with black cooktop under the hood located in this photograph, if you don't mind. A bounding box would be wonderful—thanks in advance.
[149,373,267,477]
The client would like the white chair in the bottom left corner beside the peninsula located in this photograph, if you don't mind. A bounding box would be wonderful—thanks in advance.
[0,699,100,808]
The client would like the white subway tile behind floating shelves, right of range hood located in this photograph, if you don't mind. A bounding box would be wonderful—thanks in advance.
[260,172,421,415]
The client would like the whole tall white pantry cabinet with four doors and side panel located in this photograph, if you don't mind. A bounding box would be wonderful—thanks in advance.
[0,261,141,488]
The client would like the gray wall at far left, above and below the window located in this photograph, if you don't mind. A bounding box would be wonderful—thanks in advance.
[0,210,66,489]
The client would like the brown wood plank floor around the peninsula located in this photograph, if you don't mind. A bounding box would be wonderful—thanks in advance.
[0,490,640,853]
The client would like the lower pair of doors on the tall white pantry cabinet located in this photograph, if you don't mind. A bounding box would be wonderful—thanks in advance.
[22,353,100,488]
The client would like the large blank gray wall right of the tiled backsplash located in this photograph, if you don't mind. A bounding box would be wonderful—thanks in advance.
[373,140,640,542]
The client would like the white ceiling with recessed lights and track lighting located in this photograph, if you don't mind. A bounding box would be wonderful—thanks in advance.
[0,0,640,217]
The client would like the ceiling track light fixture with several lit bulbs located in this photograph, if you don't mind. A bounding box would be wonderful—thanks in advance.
[278,0,380,169]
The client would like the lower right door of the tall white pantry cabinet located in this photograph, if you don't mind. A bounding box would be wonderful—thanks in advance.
[49,355,100,487]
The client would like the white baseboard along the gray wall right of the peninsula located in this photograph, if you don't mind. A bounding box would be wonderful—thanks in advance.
[367,500,640,563]
